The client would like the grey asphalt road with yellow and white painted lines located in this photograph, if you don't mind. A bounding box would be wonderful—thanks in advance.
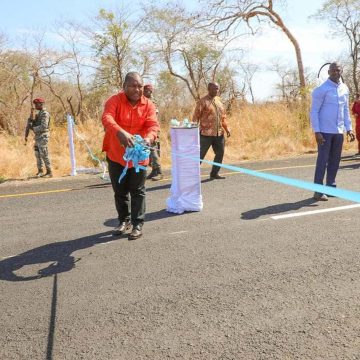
[0,156,360,360]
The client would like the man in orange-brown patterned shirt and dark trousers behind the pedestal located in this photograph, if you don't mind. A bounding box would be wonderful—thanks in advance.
[193,82,230,180]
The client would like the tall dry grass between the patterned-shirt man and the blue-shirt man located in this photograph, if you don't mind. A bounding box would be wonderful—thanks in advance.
[225,103,316,162]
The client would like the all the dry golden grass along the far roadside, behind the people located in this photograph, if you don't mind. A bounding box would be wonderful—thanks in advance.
[0,104,356,179]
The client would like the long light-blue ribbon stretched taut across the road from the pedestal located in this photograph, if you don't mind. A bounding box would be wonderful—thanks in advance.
[174,153,360,203]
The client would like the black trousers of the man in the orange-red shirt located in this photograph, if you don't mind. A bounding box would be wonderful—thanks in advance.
[107,159,146,226]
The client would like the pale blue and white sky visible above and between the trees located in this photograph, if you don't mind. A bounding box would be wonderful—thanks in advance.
[0,0,346,100]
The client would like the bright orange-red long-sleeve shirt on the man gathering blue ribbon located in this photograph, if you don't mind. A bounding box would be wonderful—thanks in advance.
[101,92,160,167]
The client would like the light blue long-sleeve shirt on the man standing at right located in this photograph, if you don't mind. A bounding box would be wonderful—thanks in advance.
[310,79,352,134]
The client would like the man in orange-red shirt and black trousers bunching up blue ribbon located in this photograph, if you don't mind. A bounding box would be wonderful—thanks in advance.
[101,72,160,240]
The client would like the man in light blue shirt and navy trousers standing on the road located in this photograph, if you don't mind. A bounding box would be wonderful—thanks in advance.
[310,62,355,201]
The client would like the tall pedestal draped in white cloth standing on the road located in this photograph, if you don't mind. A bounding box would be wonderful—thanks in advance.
[166,127,203,214]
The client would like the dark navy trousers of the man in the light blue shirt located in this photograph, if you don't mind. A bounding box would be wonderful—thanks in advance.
[314,133,344,186]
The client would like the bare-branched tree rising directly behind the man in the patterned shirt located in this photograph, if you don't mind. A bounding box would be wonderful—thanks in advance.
[145,6,231,100]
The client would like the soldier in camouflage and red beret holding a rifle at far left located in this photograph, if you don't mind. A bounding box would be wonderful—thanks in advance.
[25,98,53,177]
